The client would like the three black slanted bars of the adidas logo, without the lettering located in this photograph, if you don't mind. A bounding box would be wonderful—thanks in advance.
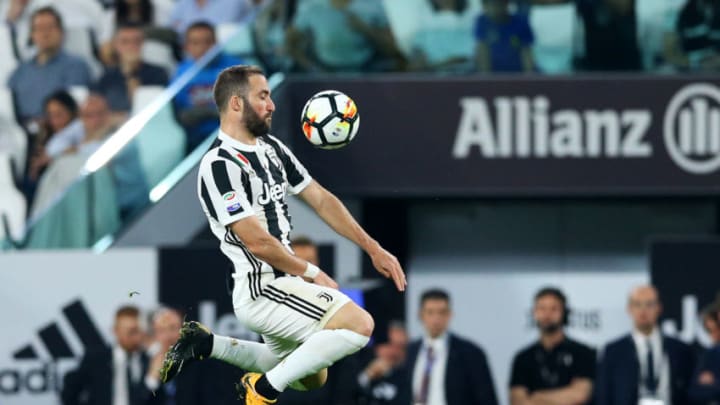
[13,300,105,360]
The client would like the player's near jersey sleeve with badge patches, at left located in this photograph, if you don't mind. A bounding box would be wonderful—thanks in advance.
[200,159,255,226]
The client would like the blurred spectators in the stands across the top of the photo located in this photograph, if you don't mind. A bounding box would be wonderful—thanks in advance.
[0,0,720,241]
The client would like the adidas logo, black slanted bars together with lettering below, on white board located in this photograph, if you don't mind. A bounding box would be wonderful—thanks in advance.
[0,300,105,392]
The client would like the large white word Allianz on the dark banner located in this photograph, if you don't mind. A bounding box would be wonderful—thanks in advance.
[452,96,653,159]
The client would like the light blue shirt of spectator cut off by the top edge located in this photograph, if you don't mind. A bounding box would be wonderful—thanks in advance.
[170,0,263,34]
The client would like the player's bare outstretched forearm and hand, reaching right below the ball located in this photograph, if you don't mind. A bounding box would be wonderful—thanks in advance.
[299,180,407,291]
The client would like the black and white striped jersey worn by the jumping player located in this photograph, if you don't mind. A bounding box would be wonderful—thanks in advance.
[198,131,312,282]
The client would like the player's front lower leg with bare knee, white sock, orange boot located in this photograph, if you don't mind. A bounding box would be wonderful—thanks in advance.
[238,302,374,405]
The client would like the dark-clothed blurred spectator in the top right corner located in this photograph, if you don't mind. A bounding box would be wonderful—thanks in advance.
[664,0,720,71]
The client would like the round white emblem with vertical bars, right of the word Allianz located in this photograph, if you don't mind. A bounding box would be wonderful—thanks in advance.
[663,83,720,174]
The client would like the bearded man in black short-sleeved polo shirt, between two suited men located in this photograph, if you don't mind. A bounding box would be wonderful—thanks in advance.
[510,287,596,405]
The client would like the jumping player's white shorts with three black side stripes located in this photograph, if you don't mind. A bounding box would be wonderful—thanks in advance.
[233,276,350,359]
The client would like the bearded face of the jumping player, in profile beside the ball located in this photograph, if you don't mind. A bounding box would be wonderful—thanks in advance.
[243,75,275,137]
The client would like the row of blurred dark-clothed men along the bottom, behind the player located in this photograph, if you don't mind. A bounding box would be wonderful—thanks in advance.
[57,284,720,405]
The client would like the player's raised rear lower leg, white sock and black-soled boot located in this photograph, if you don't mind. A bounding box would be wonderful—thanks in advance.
[160,321,280,383]
